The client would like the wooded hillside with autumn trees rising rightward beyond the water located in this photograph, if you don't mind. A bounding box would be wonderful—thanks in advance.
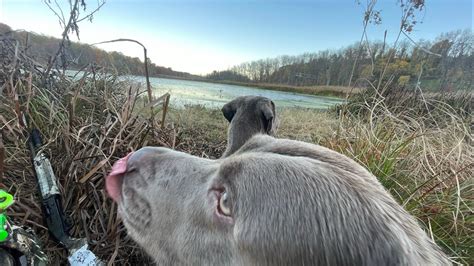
[207,30,474,90]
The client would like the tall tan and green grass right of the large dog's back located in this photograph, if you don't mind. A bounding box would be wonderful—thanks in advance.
[322,93,474,265]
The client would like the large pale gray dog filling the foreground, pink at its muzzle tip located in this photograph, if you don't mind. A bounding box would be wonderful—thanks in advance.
[106,135,449,265]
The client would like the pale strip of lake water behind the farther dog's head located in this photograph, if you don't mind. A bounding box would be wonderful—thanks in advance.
[129,77,343,109]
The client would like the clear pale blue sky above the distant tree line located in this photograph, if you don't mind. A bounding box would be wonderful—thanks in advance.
[0,0,474,74]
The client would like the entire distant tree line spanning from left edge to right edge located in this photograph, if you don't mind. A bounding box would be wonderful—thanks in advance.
[0,23,474,90]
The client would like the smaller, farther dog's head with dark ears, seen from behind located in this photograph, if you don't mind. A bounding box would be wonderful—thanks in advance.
[222,96,278,157]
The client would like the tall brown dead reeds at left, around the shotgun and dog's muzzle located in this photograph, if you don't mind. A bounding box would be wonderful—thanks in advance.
[0,33,170,265]
